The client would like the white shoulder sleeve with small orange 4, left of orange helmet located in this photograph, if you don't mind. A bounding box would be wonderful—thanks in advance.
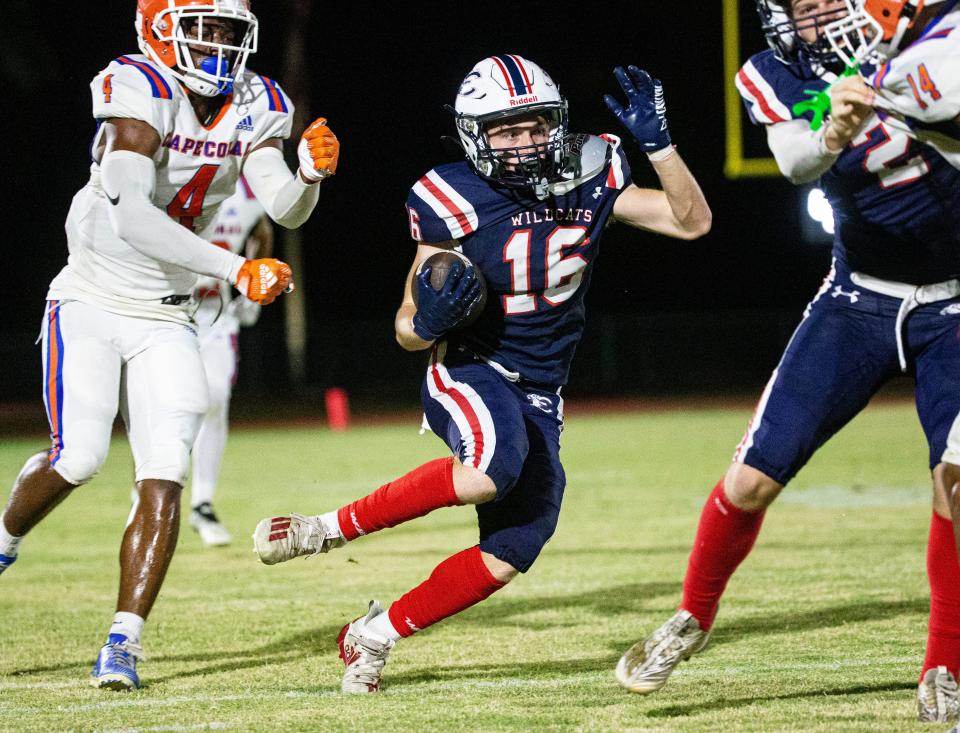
[90,56,177,140]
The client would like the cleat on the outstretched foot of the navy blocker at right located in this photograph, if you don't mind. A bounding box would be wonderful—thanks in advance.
[615,610,710,695]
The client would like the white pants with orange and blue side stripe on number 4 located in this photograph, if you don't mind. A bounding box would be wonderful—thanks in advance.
[42,300,208,485]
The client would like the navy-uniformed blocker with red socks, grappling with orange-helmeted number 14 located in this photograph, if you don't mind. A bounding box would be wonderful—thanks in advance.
[617,0,960,720]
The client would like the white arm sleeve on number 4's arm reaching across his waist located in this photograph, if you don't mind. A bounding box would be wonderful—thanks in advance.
[100,150,244,283]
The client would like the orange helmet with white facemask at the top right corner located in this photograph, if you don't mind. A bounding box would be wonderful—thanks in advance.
[826,0,944,66]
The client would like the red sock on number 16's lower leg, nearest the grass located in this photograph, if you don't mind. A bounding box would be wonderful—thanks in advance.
[388,545,506,636]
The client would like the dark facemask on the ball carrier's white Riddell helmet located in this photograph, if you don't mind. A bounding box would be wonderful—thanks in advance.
[456,100,571,199]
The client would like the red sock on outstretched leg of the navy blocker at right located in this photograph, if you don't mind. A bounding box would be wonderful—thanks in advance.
[680,479,764,631]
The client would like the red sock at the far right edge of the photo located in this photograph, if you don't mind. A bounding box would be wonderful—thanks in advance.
[920,513,960,678]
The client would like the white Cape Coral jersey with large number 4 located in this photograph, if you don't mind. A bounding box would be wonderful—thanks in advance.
[47,55,294,321]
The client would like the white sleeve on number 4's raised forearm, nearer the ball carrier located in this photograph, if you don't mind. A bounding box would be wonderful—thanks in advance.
[243,147,320,229]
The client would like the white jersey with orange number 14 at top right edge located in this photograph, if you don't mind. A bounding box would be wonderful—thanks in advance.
[868,9,960,168]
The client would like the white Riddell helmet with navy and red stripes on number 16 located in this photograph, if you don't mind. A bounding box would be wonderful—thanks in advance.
[451,54,570,198]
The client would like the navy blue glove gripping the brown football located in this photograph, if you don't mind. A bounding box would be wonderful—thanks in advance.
[413,262,481,341]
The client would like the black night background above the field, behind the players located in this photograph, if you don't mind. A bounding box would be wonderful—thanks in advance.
[0,0,844,417]
